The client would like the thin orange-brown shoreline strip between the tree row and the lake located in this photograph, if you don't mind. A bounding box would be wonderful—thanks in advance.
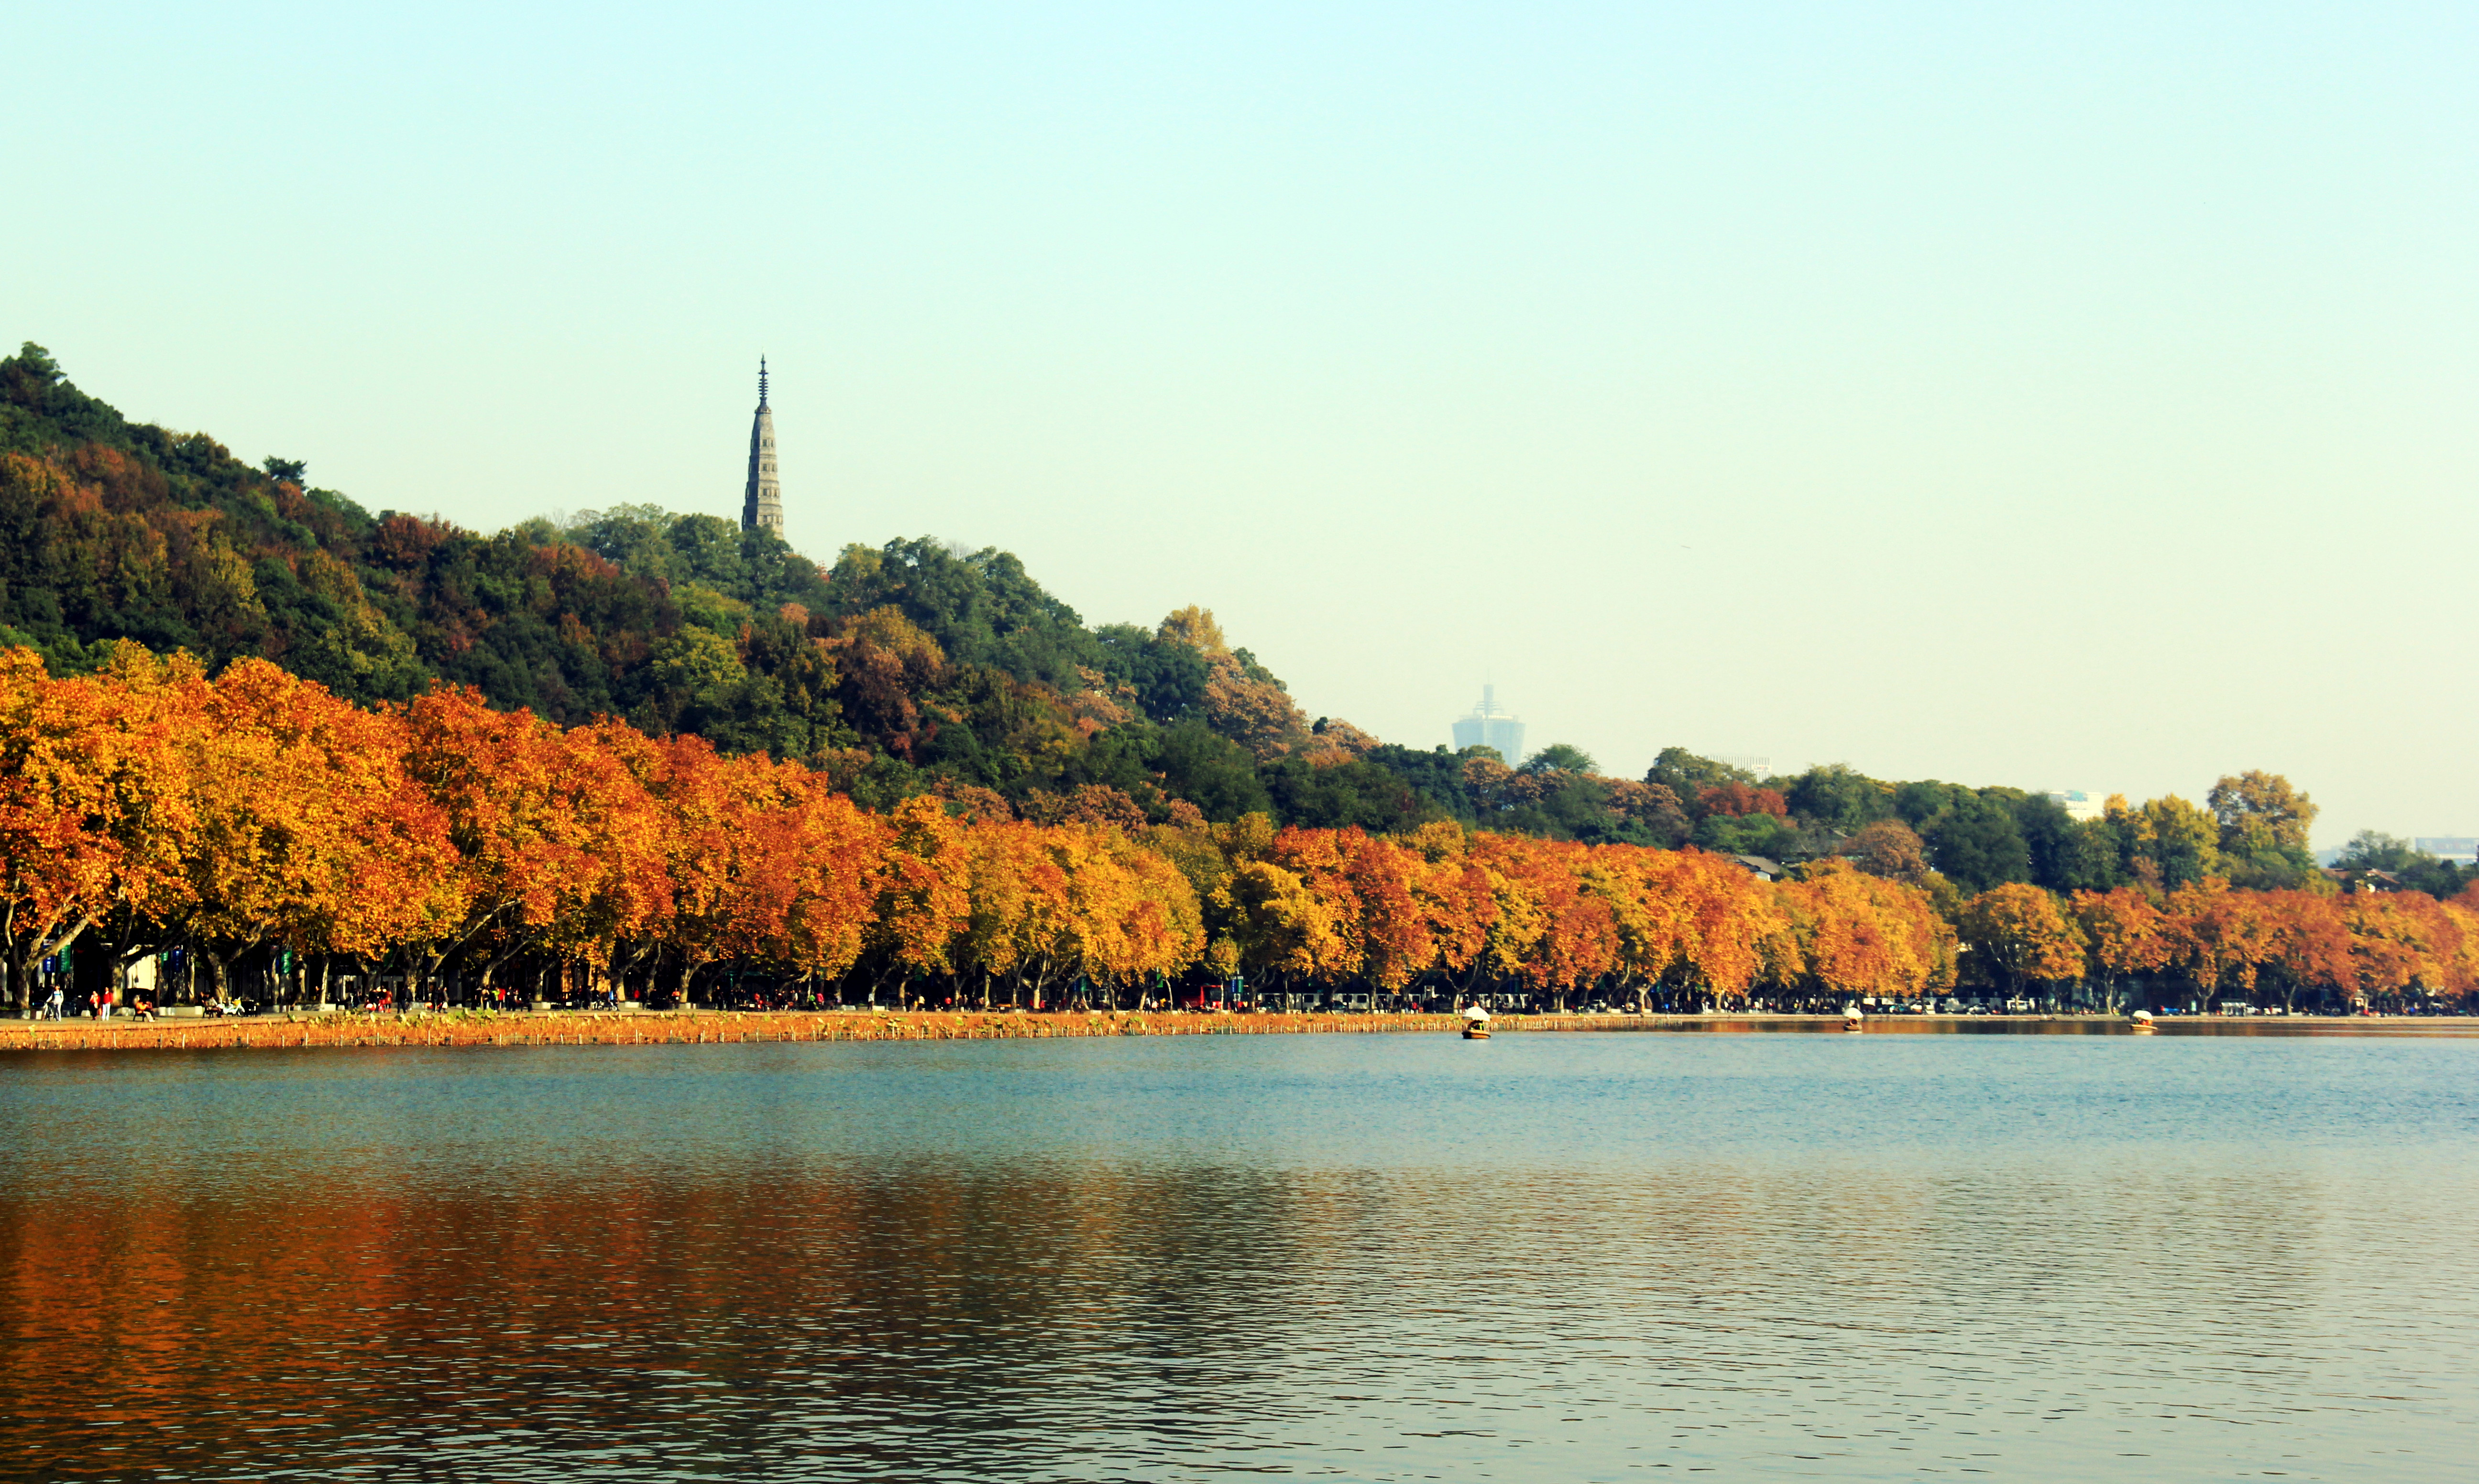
[0,1011,2479,1050]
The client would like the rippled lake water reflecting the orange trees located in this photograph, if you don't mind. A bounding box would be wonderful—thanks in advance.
[0,1036,2479,1482]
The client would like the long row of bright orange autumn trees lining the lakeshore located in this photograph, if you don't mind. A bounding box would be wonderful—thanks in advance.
[0,644,2479,1008]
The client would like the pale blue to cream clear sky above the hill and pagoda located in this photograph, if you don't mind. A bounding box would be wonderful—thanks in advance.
[0,2,2479,842]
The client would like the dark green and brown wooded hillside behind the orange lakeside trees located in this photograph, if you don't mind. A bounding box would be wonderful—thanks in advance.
[0,344,2467,897]
